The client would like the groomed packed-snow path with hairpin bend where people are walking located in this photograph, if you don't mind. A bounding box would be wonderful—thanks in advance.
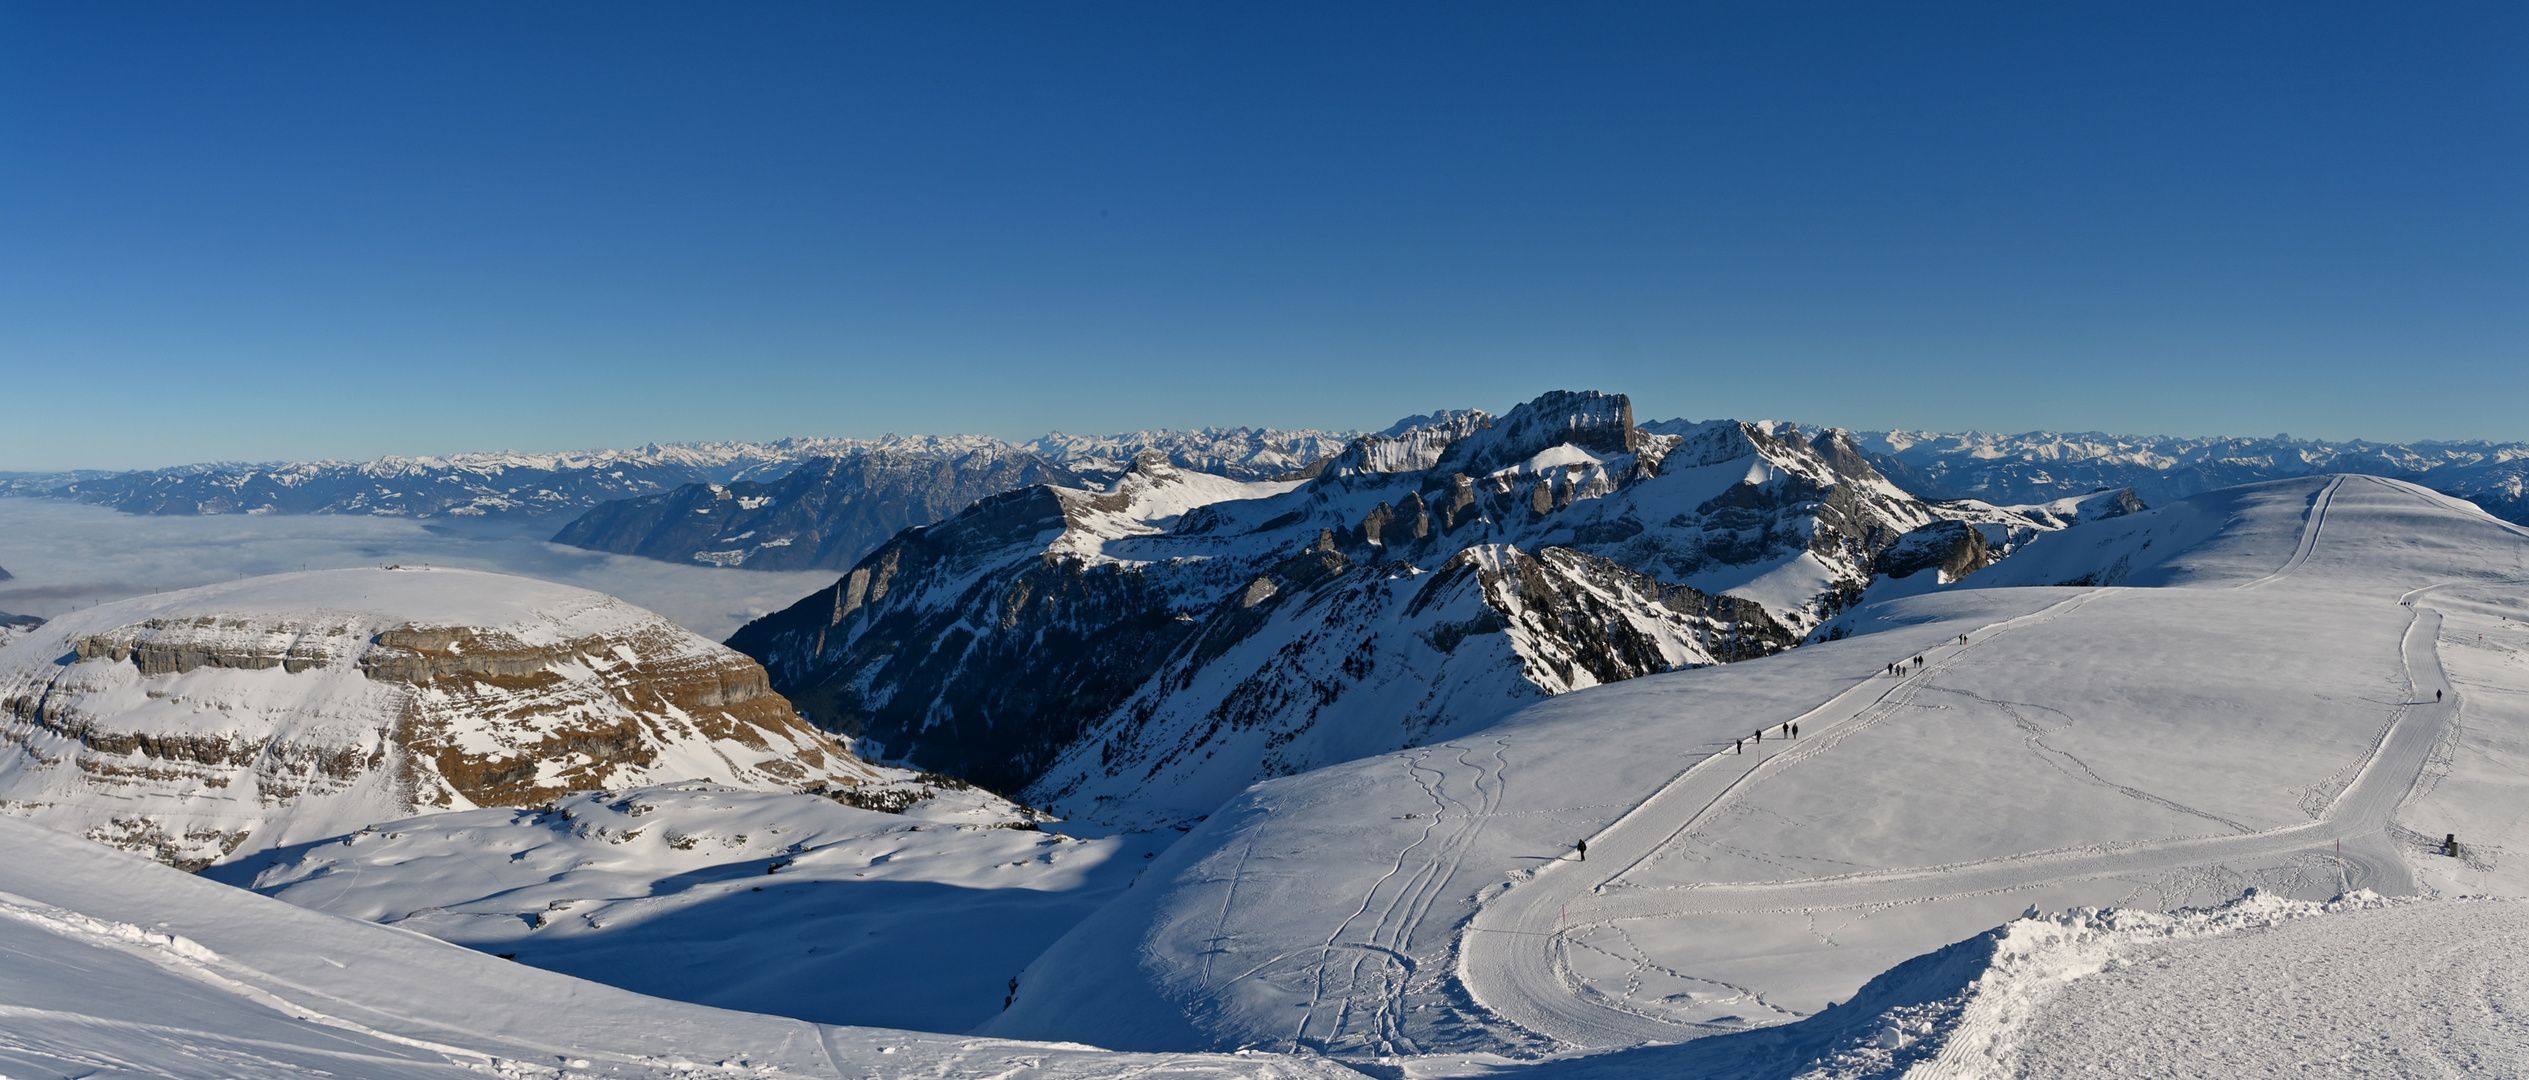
[1459,478,2458,1047]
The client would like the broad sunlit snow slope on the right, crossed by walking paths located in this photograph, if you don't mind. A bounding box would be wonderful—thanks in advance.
[981,476,2529,1055]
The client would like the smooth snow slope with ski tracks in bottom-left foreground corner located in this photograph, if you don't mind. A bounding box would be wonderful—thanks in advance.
[0,819,1358,1080]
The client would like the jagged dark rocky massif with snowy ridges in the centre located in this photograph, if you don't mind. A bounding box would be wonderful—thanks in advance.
[731,392,1992,819]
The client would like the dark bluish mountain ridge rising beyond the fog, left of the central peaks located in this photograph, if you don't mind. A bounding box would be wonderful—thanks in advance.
[554,445,1082,569]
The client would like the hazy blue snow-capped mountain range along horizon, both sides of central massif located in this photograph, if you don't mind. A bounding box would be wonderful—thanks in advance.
[19,422,2529,584]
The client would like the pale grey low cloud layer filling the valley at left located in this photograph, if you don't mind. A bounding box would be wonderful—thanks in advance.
[0,498,835,640]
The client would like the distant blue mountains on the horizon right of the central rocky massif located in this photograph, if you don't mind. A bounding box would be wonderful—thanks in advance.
[1856,430,2529,524]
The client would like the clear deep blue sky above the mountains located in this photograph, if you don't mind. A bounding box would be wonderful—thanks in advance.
[0,3,2529,470]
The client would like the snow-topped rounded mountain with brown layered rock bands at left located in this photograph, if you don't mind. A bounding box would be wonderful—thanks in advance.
[0,569,875,868]
